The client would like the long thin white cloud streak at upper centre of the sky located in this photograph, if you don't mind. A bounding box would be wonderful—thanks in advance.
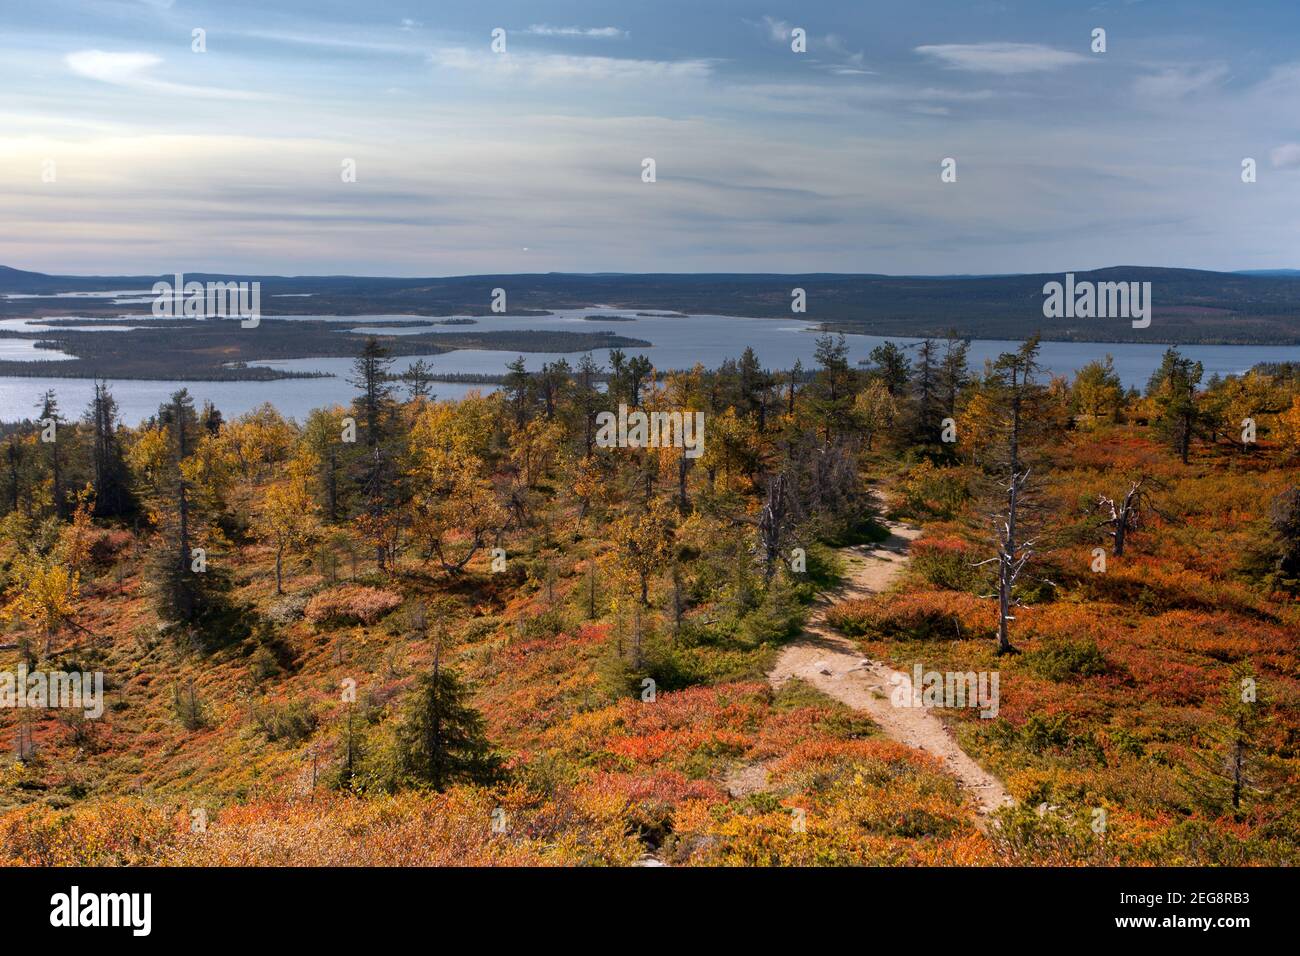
[429,47,712,82]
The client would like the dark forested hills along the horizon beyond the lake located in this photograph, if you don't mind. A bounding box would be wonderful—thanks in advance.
[0,265,1300,345]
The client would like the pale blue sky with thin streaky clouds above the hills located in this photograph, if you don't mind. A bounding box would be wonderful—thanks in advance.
[0,0,1300,276]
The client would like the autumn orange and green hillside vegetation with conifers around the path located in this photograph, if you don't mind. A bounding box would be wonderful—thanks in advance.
[0,336,1300,865]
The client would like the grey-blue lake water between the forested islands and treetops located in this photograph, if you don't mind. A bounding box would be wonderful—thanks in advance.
[0,308,1300,425]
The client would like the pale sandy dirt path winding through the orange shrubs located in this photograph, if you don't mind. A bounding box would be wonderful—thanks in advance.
[764,509,1013,816]
